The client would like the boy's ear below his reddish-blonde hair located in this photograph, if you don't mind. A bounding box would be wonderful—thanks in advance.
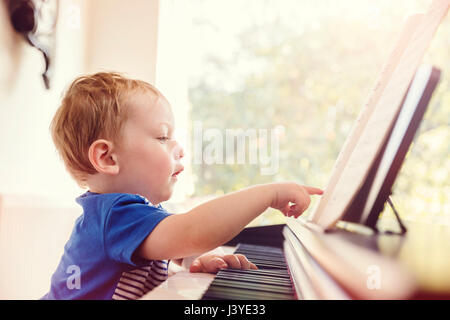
[88,139,119,175]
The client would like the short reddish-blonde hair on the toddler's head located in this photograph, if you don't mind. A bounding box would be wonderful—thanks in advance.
[50,72,162,187]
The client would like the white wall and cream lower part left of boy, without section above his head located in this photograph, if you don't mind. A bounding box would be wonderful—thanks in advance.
[0,0,90,299]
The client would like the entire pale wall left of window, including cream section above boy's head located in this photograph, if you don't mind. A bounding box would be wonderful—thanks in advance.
[0,0,162,299]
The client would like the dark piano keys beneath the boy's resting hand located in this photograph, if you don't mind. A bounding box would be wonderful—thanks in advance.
[202,244,296,300]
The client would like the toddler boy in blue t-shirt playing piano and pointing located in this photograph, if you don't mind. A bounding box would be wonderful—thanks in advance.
[43,72,322,299]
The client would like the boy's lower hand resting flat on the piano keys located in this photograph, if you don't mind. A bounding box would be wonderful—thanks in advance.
[189,254,258,273]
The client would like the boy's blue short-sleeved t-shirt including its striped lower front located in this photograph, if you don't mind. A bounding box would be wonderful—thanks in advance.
[42,191,170,300]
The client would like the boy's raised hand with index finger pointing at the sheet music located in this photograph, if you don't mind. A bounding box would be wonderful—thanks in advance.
[270,182,323,218]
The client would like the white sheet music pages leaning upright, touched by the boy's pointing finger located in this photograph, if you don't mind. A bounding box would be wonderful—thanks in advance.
[311,0,450,229]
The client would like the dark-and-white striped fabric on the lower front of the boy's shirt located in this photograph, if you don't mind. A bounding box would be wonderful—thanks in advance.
[112,260,168,300]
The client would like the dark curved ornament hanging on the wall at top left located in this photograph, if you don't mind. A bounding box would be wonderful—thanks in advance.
[6,0,59,89]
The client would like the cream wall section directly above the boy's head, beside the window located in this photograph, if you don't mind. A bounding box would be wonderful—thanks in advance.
[86,0,159,84]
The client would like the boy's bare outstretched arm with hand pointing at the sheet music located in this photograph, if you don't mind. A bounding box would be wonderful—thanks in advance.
[138,183,322,260]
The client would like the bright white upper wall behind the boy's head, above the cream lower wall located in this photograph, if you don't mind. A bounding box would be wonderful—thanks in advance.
[0,0,85,200]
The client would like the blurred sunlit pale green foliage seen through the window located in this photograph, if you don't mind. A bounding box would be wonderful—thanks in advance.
[189,1,450,223]
